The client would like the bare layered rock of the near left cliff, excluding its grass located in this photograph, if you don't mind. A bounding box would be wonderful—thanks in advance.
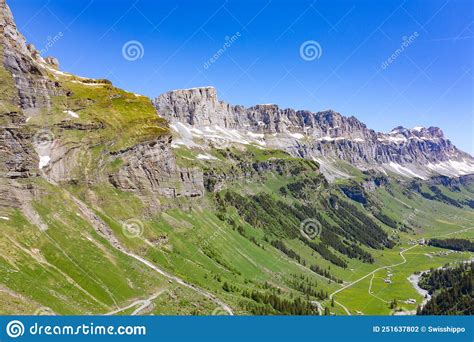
[0,0,204,203]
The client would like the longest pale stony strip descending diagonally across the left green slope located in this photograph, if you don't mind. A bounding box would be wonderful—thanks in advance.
[69,193,234,315]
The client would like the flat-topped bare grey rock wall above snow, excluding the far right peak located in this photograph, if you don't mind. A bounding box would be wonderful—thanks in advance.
[154,87,371,138]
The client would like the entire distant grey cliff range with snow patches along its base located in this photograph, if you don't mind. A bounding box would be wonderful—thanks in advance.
[154,87,474,177]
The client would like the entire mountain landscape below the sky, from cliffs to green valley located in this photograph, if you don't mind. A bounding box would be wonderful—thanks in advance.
[0,0,474,315]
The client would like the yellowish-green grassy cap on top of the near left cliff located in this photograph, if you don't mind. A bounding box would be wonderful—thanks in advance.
[36,72,169,151]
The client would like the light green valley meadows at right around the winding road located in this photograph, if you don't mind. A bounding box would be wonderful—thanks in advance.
[335,180,474,314]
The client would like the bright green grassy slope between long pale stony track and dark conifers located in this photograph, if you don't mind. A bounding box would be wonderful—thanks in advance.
[68,183,334,313]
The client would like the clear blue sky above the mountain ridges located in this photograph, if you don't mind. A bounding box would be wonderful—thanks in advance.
[7,0,474,154]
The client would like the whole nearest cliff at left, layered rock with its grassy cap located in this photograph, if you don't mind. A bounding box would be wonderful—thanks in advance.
[0,0,204,203]
